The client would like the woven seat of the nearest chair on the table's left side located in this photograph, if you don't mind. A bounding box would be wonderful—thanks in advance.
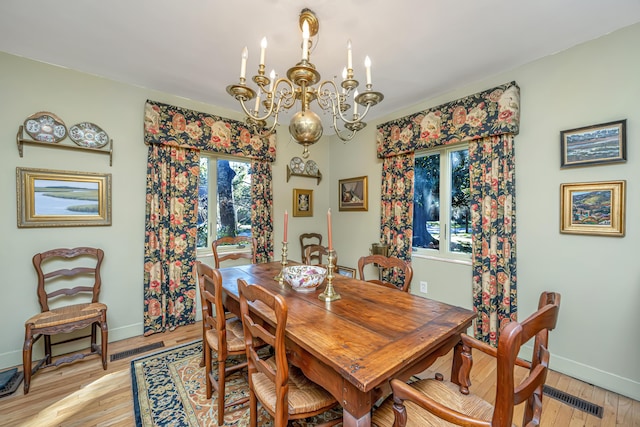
[252,357,337,415]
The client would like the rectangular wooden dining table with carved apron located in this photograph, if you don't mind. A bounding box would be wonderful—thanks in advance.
[220,262,474,427]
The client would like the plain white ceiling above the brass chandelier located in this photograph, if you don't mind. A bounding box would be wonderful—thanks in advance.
[0,0,640,129]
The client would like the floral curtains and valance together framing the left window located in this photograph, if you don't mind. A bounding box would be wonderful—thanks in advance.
[144,101,276,335]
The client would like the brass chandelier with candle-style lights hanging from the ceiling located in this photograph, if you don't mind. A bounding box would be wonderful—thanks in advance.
[227,9,384,158]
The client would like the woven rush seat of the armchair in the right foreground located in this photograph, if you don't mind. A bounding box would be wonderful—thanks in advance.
[372,379,493,427]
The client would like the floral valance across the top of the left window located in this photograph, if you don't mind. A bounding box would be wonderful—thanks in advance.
[144,100,276,162]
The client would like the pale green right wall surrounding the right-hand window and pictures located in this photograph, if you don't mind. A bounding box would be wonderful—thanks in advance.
[330,25,640,400]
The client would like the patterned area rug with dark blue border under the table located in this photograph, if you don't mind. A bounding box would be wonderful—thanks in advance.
[131,341,341,427]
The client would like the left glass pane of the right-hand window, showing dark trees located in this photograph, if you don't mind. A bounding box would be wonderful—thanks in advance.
[413,154,440,249]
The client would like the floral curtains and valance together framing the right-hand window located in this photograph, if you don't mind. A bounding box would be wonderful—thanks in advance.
[377,82,520,344]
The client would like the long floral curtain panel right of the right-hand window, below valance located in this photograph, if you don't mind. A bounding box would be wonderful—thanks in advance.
[469,134,518,346]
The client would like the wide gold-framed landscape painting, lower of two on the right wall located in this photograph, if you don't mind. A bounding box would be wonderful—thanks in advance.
[560,180,626,237]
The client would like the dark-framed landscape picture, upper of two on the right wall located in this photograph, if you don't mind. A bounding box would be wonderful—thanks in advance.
[560,120,627,168]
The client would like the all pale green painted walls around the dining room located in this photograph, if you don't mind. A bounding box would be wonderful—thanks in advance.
[0,20,640,399]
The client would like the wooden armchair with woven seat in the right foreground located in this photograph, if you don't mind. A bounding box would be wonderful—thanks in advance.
[372,292,560,427]
